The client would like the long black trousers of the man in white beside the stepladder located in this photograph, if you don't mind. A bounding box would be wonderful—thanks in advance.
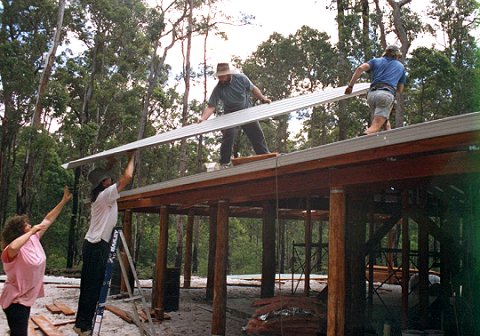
[75,240,109,330]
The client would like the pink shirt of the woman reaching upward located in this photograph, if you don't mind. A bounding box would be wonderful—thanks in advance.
[0,233,47,309]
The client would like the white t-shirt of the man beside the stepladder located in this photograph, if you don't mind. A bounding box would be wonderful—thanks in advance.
[85,184,120,243]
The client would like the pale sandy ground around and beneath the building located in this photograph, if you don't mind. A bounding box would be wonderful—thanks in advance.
[0,276,325,336]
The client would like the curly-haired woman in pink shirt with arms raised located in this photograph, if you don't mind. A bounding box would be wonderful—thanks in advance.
[0,187,72,336]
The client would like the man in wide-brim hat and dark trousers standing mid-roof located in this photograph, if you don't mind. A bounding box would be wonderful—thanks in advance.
[200,63,271,167]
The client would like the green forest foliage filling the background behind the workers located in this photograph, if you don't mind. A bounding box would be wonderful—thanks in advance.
[0,0,480,277]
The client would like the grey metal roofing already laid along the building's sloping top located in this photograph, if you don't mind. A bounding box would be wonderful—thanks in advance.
[120,112,480,197]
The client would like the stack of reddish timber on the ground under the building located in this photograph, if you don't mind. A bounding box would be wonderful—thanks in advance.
[245,296,327,336]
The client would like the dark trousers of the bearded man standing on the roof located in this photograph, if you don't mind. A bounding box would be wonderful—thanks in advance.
[220,121,269,164]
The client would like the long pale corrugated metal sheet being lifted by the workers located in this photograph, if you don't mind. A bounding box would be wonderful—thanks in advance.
[62,83,370,169]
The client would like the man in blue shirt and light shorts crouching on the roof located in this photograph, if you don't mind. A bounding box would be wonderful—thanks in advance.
[345,45,406,135]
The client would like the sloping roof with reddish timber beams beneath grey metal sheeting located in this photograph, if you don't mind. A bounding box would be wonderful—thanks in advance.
[118,112,480,211]
